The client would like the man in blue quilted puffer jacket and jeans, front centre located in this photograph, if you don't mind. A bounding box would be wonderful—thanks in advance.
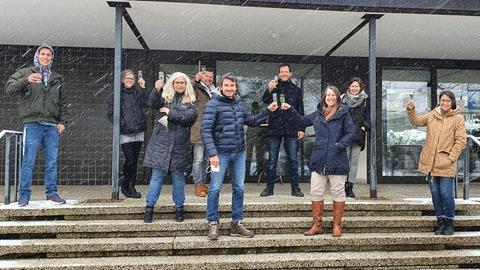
[201,73,278,240]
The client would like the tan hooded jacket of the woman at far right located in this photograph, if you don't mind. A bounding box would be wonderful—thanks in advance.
[407,106,467,177]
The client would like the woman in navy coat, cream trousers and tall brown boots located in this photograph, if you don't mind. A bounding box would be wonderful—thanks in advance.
[282,86,355,237]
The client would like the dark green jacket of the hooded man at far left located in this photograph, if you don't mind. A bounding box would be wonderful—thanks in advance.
[6,66,67,124]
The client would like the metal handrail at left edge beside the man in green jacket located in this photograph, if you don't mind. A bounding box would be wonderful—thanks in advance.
[0,130,23,204]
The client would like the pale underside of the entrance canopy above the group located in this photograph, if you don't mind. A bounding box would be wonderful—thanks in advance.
[0,0,480,60]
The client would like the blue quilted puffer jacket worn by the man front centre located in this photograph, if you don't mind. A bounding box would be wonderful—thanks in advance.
[202,95,268,157]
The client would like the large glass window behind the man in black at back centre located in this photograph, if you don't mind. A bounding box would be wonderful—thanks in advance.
[217,61,321,175]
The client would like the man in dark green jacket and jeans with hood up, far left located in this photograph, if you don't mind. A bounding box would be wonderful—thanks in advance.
[6,45,67,206]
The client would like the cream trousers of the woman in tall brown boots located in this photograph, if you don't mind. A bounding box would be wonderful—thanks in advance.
[310,172,347,202]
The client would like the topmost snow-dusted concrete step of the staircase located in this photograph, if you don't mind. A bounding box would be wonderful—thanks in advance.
[0,199,480,221]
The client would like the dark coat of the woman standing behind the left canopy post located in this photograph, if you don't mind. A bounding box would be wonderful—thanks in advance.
[107,86,148,135]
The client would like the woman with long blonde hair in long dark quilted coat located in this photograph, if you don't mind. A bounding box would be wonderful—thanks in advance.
[143,72,197,223]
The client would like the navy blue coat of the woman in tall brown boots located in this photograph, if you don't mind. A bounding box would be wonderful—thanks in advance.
[287,105,355,175]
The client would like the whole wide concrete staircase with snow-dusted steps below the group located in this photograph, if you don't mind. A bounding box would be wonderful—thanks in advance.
[0,200,480,270]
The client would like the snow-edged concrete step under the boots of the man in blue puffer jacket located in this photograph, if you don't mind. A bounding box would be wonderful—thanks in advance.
[0,232,480,259]
